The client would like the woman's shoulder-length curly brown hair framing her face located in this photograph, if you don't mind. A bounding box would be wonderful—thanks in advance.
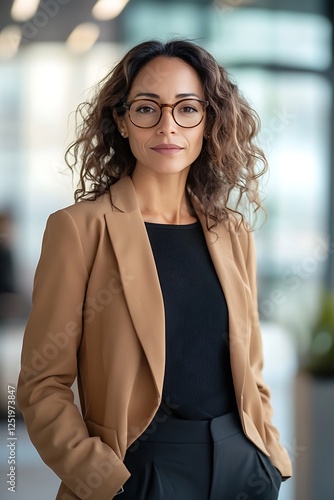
[65,39,267,228]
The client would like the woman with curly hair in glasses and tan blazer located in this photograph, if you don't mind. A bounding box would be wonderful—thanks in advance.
[18,40,291,500]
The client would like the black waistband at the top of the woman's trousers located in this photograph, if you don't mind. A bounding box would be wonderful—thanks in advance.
[138,411,242,443]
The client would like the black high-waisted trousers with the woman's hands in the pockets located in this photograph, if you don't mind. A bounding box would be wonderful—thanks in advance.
[121,412,281,500]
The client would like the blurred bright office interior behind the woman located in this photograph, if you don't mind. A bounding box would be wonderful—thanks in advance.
[0,0,334,500]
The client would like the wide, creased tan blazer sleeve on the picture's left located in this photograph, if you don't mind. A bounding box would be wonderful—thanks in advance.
[17,210,130,500]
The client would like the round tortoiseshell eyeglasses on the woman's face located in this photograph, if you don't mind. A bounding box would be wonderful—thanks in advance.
[123,99,209,128]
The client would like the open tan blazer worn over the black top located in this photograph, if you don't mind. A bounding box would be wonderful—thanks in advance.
[18,177,291,500]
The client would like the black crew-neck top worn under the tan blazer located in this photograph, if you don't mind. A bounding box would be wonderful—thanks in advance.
[145,222,236,420]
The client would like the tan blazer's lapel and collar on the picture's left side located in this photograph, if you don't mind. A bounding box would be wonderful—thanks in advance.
[105,177,165,396]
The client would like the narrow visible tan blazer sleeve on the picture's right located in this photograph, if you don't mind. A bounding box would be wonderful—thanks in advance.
[246,231,292,478]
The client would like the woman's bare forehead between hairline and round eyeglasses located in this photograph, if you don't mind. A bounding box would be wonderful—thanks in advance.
[130,56,204,98]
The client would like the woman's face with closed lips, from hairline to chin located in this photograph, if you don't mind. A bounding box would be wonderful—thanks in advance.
[119,57,205,179]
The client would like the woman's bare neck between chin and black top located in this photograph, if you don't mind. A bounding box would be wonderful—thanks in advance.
[132,169,196,224]
